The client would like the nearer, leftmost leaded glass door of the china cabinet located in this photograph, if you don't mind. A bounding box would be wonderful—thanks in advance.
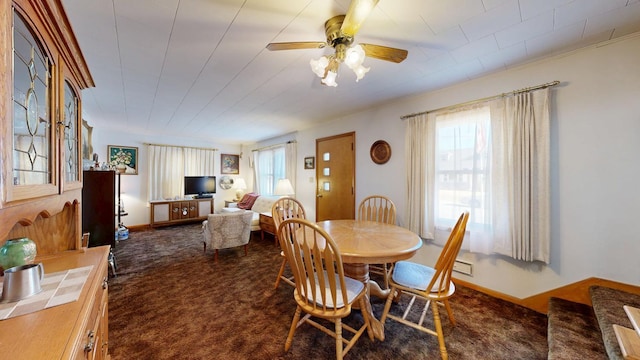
[4,11,58,201]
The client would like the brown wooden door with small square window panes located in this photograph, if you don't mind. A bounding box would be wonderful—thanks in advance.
[316,132,356,221]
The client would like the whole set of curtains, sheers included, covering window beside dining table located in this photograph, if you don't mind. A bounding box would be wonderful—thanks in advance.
[405,88,550,263]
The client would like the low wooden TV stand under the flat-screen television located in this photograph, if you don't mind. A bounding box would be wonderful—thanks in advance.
[149,198,213,227]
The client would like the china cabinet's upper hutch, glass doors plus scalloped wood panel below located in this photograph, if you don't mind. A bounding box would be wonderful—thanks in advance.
[0,0,94,250]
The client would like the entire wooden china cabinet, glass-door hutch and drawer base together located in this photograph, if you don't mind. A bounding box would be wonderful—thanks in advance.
[0,0,104,359]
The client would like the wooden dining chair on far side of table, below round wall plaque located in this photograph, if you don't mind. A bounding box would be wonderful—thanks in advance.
[358,195,396,289]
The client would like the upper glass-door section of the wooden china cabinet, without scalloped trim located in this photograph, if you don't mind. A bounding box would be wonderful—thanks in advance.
[0,0,93,207]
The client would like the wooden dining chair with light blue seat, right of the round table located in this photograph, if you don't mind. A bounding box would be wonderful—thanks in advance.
[380,212,469,360]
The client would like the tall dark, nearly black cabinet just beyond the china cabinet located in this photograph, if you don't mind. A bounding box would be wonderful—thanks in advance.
[82,171,116,247]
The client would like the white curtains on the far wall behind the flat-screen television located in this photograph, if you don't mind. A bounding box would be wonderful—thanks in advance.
[148,145,215,201]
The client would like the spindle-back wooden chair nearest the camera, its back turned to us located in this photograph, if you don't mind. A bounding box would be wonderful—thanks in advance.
[278,218,373,360]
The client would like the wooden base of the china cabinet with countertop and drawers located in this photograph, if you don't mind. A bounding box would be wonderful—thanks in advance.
[0,246,109,360]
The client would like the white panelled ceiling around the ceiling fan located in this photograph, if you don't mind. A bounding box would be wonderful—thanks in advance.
[62,0,640,143]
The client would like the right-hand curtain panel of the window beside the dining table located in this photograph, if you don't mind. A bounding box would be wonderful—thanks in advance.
[491,88,551,263]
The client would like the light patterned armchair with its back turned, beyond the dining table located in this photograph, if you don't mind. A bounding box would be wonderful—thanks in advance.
[202,211,253,263]
